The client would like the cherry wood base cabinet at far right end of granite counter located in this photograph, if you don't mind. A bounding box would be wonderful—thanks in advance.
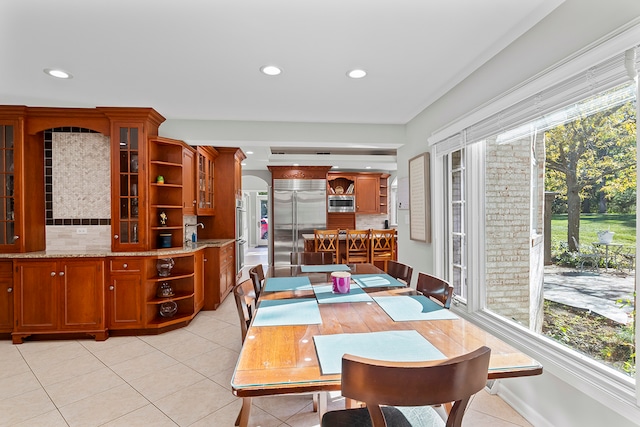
[204,241,236,310]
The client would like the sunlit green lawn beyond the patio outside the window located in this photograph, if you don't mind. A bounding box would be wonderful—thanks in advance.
[551,214,636,246]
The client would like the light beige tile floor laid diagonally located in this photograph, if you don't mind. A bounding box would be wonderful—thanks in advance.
[0,246,530,427]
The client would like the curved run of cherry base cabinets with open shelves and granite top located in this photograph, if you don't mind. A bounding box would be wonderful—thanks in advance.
[0,239,235,344]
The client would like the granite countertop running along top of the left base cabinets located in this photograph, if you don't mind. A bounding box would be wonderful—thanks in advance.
[0,239,235,259]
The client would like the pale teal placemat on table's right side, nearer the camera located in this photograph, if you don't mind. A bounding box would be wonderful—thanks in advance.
[373,295,458,322]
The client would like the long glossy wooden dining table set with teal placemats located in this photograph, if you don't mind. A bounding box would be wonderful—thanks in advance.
[231,264,542,427]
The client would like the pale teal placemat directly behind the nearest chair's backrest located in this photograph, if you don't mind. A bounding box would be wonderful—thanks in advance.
[313,331,446,375]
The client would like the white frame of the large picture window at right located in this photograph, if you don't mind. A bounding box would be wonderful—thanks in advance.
[428,22,640,419]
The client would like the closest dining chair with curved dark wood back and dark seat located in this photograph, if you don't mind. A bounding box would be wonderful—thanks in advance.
[322,346,491,427]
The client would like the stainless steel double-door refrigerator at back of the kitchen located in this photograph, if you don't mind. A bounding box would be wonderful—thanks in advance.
[269,179,327,265]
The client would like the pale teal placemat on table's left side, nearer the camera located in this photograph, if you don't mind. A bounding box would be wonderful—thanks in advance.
[253,298,322,326]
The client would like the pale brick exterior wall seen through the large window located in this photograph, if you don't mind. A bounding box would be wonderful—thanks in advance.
[485,137,544,327]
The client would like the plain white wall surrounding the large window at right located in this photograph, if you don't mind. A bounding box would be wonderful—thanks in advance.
[398,0,640,427]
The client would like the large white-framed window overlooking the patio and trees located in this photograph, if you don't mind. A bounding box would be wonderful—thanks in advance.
[430,40,640,408]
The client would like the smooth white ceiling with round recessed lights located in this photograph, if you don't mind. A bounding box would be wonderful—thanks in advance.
[0,0,562,169]
